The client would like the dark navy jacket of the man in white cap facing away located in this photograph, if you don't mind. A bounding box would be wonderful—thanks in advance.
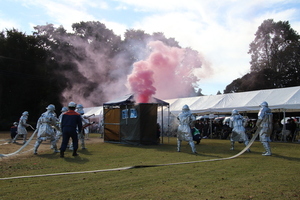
[61,110,82,133]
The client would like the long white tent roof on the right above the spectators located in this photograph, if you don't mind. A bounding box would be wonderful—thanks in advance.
[164,86,300,115]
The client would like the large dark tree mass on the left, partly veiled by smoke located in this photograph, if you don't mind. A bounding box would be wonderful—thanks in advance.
[0,21,190,130]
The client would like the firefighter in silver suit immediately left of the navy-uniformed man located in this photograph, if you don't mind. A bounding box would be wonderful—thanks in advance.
[33,104,59,155]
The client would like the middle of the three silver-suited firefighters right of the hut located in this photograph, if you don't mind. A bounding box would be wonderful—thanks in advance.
[229,109,250,152]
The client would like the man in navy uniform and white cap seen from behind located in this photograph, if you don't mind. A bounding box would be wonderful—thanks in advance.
[60,102,82,158]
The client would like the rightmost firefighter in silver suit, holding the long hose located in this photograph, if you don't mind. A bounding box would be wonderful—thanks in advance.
[256,101,273,156]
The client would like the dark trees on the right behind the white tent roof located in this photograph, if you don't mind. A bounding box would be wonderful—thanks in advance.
[224,19,300,93]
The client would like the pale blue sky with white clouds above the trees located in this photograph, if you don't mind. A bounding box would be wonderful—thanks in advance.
[0,0,300,95]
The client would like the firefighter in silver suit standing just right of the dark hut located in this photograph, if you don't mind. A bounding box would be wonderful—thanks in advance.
[177,105,197,154]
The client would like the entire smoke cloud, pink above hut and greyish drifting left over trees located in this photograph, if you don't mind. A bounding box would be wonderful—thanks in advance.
[44,22,212,107]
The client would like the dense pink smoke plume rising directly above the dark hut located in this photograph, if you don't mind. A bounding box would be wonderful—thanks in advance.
[127,41,209,103]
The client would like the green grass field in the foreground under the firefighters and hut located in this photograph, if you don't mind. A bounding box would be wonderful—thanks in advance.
[0,134,300,200]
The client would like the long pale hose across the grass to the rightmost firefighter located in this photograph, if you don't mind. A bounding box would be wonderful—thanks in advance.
[0,131,258,180]
